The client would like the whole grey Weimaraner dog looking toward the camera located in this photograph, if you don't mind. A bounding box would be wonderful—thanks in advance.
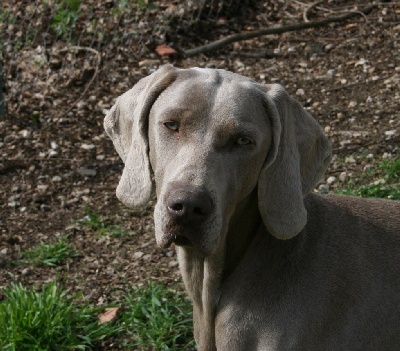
[104,65,400,351]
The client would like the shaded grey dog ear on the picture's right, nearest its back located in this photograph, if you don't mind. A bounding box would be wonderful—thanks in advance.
[256,84,332,239]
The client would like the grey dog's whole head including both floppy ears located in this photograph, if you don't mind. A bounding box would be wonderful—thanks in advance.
[104,65,331,255]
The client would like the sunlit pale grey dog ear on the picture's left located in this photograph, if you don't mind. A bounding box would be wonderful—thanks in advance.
[104,65,178,207]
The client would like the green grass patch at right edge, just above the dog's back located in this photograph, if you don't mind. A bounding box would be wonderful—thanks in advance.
[339,159,400,200]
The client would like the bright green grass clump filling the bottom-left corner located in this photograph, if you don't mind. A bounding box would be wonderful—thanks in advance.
[0,281,119,351]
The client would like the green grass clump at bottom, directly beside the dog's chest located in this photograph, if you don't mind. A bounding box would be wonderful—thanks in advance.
[121,283,194,351]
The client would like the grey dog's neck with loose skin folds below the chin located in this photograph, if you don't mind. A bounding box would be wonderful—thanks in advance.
[178,191,262,351]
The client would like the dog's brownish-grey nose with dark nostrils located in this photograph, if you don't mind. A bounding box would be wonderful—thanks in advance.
[167,188,212,225]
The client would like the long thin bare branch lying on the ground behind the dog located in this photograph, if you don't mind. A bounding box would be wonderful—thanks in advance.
[183,5,376,57]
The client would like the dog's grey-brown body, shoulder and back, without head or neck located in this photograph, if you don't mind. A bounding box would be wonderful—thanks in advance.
[216,194,400,351]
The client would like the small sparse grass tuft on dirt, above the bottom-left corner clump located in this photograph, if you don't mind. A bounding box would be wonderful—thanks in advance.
[24,236,78,266]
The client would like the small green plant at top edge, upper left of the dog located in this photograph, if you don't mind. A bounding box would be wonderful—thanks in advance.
[51,0,80,36]
